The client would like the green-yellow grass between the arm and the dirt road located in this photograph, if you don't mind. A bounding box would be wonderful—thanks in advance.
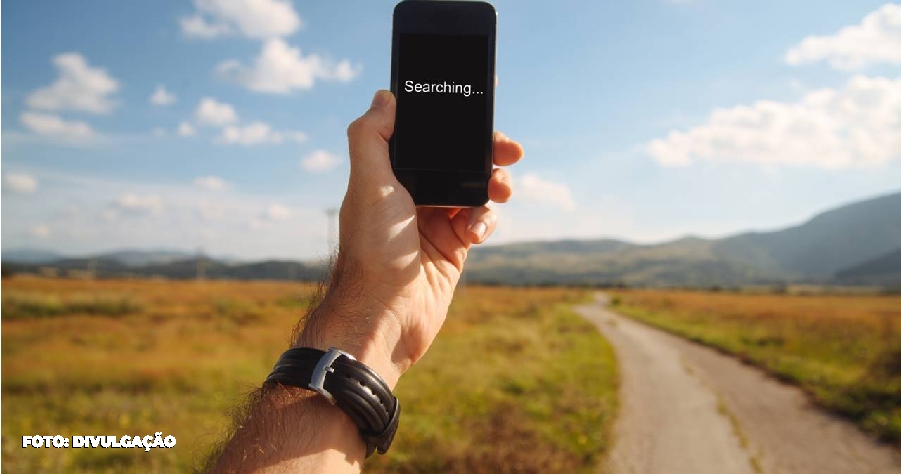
[365,289,617,473]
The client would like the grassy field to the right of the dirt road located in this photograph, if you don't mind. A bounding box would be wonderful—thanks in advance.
[613,291,901,447]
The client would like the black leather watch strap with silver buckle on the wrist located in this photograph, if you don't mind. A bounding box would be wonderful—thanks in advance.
[266,347,400,457]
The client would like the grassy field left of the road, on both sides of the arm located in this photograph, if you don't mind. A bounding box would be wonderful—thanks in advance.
[2,279,617,473]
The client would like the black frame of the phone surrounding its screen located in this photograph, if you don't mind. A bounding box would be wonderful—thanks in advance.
[389,0,497,207]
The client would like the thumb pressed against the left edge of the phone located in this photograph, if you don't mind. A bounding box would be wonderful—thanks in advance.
[347,90,397,187]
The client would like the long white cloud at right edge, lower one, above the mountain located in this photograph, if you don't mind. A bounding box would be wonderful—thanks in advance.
[647,76,901,169]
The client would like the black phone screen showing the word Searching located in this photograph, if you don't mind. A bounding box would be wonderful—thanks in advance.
[394,34,493,171]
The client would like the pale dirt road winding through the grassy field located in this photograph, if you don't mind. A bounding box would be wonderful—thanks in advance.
[577,296,901,474]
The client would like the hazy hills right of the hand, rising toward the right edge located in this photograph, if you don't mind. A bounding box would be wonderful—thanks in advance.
[467,193,901,286]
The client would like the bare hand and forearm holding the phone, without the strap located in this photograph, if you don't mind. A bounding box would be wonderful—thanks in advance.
[200,91,522,474]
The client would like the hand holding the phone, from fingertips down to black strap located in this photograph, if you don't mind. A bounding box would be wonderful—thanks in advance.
[295,91,523,387]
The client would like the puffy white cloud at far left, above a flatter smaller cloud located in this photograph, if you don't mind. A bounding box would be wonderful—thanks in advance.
[25,53,119,114]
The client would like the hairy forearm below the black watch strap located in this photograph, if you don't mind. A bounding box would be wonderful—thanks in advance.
[209,386,366,474]
